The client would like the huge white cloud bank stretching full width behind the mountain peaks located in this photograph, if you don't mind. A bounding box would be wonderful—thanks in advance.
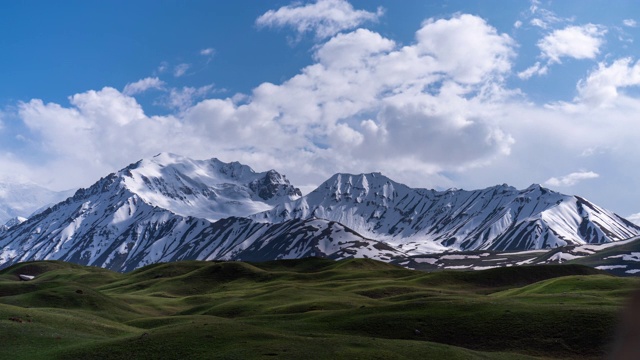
[8,11,640,217]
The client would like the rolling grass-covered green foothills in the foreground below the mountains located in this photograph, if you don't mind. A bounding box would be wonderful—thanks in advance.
[0,258,640,359]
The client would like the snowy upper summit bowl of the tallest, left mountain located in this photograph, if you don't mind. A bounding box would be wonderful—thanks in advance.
[107,153,302,220]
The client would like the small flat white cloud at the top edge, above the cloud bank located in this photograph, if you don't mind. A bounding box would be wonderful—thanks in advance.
[256,0,384,39]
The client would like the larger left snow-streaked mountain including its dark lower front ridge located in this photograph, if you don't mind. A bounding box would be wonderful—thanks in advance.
[0,154,403,271]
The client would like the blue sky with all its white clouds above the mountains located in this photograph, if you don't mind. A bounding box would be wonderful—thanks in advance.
[0,0,640,219]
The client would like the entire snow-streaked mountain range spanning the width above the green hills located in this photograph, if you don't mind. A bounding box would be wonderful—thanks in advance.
[0,153,640,271]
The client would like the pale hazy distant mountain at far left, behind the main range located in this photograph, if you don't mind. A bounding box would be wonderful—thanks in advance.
[0,180,73,224]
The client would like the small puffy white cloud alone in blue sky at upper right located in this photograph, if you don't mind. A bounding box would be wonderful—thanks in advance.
[538,24,607,63]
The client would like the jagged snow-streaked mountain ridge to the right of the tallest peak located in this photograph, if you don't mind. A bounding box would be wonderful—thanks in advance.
[252,173,640,254]
